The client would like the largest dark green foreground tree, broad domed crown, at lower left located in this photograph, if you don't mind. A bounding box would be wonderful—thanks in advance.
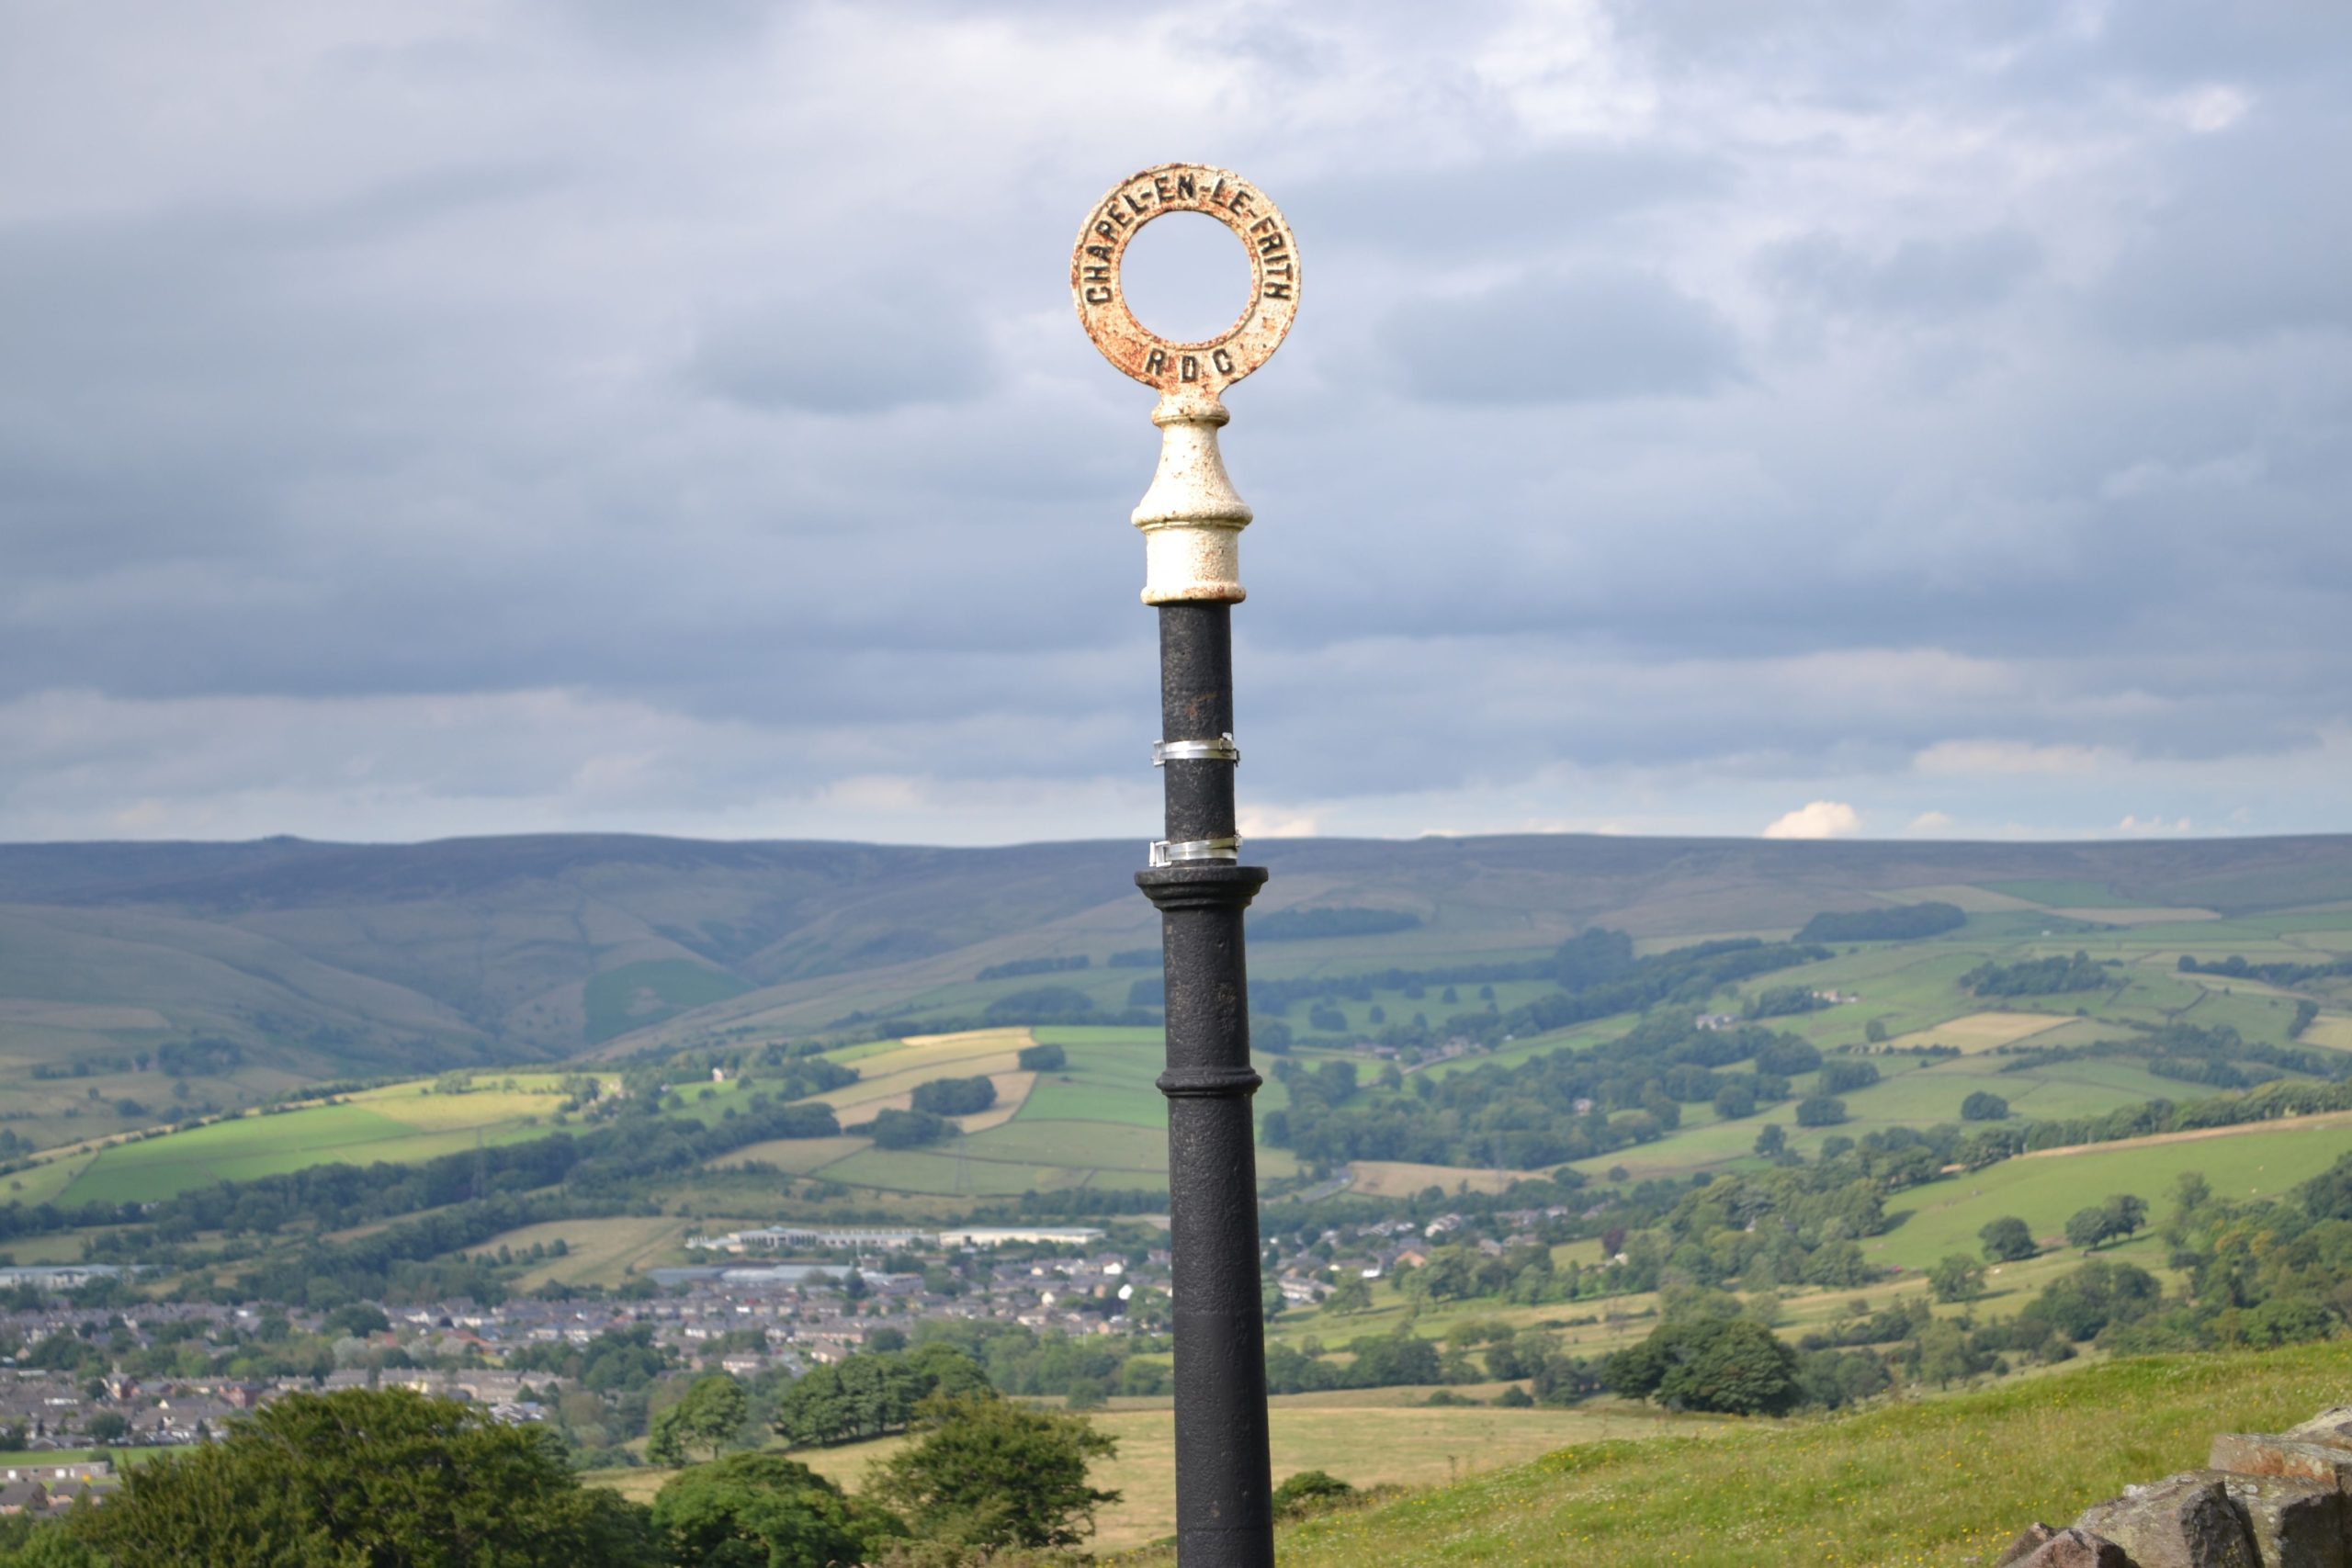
[66,1389,659,1568]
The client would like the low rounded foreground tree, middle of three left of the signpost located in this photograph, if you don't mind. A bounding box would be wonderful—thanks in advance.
[654,1453,896,1568]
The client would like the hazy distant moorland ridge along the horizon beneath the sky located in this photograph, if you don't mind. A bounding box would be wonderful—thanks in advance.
[0,835,2352,1081]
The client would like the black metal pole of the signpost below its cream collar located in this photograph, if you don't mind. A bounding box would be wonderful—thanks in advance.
[1136,602,1275,1568]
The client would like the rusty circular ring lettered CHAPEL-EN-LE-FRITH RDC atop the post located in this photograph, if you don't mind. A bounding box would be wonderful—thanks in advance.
[1070,163,1298,404]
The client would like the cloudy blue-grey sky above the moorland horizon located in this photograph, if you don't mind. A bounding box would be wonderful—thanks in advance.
[0,0,2352,844]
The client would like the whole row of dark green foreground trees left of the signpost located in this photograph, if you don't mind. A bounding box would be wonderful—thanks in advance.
[0,1387,1120,1568]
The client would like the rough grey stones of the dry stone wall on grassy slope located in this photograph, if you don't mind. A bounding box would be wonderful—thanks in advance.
[1995,1405,2352,1568]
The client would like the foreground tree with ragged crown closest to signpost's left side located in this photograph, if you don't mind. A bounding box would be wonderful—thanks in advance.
[865,1394,1120,1547]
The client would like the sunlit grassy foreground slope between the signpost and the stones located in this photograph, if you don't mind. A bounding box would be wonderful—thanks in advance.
[1232,1342,2352,1568]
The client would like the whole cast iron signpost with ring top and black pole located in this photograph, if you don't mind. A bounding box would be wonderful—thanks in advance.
[1070,163,1298,1568]
